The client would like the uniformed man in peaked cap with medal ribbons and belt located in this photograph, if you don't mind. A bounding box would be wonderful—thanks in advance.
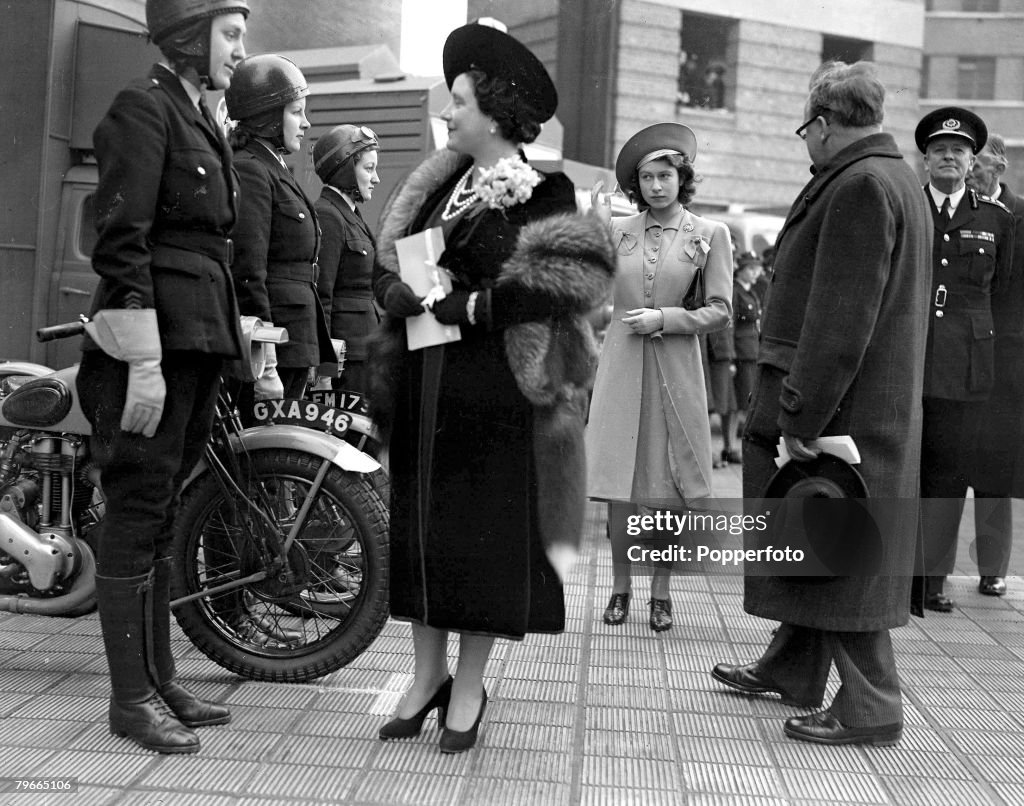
[914,107,1021,612]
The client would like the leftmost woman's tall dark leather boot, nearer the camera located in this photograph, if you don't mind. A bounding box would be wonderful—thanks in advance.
[96,571,199,753]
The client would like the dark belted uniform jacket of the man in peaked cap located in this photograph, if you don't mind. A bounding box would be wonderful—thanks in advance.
[924,185,1020,400]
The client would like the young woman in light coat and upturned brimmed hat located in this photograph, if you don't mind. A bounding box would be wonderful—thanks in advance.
[587,123,732,632]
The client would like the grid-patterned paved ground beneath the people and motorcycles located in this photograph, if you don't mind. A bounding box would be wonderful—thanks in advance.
[0,467,1024,806]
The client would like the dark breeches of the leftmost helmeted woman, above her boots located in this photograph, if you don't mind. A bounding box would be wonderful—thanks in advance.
[77,350,221,578]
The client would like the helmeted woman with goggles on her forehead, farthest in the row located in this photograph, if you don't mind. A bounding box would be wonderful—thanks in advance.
[313,124,380,392]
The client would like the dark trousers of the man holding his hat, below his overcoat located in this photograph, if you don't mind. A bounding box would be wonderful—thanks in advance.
[758,624,903,727]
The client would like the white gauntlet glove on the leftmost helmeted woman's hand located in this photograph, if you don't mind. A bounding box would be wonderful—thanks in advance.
[85,308,167,436]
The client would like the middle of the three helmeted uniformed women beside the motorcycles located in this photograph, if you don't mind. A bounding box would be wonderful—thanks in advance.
[224,53,335,409]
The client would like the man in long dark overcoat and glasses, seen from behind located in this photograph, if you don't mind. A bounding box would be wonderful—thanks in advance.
[712,61,931,745]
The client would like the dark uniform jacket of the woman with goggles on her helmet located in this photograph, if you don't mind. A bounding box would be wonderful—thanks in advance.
[313,185,381,362]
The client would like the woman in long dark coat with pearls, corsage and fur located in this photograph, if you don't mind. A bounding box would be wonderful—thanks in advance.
[370,25,613,753]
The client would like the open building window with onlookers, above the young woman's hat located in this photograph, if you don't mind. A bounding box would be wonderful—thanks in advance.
[676,11,737,110]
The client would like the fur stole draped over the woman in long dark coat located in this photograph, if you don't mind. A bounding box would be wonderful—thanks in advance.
[370,151,615,569]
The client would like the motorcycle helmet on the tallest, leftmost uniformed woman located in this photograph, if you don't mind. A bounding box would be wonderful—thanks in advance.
[145,0,249,84]
